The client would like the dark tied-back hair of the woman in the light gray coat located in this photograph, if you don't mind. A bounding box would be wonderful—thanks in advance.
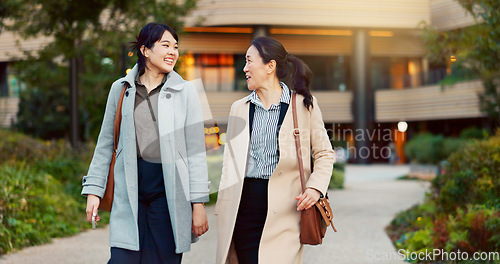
[130,23,179,75]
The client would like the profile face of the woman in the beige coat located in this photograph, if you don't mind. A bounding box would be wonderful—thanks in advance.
[243,46,270,91]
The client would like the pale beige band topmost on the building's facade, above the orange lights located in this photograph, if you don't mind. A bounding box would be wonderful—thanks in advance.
[186,0,430,28]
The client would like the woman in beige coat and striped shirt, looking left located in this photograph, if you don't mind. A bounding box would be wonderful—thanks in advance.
[215,37,334,264]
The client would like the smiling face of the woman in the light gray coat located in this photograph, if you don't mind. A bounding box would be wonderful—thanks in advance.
[143,31,179,73]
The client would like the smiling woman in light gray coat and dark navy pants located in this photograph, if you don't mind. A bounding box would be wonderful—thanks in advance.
[82,23,209,264]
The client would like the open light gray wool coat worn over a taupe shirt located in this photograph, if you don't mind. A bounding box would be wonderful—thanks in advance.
[82,65,210,253]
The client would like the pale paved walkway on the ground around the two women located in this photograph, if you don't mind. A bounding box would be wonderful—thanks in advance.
[0,165,428,264]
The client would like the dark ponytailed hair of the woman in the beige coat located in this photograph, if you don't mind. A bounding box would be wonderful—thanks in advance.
[252,37,313,109]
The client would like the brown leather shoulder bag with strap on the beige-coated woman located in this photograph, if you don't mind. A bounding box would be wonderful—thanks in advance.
[292,92,337,245]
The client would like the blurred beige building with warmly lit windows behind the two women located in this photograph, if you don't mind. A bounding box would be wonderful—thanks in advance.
[0,0,485,163]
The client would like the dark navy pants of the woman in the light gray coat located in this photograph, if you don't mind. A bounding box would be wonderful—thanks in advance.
[108,159,182,264]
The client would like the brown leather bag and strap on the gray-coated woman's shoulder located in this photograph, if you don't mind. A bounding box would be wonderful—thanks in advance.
[99,84,127,212]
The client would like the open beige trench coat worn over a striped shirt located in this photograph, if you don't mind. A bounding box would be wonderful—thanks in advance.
[215,95,334,264]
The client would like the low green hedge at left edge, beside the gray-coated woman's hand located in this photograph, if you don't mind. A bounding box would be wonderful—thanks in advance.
[0,130,94,254]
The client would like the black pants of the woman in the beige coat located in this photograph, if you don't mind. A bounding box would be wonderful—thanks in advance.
[233,178,269,264]
